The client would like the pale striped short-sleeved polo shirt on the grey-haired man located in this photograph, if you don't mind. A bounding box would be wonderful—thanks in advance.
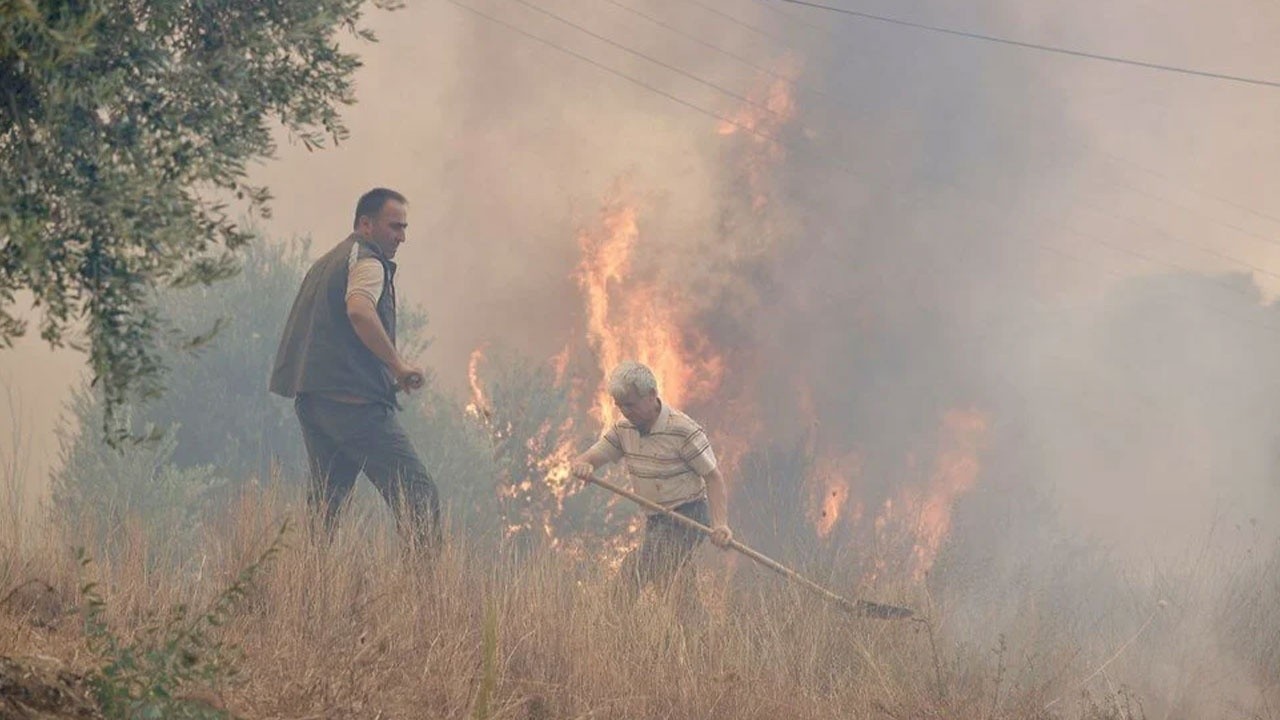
[591,404,716,507]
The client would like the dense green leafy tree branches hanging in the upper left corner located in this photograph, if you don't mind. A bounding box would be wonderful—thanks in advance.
[0,0,389,438]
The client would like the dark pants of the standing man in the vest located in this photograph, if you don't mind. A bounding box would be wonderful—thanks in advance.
[293,395,440,547]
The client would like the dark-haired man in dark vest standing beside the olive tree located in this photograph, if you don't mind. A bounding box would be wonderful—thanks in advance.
[271,187,440,546]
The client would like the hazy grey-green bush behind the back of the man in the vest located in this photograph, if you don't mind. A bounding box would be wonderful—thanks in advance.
[63,234,317,487]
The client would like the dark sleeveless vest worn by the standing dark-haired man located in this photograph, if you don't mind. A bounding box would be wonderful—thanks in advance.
[270,234,397,407]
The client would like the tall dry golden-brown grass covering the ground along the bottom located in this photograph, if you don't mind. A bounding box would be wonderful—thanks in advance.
[0,476,1280,720]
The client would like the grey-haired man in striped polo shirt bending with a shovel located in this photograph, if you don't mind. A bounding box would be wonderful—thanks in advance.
[572,361,733,605]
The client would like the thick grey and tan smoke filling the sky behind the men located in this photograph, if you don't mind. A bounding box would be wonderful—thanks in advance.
[2,0,1280,707]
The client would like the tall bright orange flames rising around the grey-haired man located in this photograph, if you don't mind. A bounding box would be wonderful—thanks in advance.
[467,184,724,556]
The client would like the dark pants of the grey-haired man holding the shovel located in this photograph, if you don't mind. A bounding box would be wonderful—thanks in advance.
[617,500,708,616]
